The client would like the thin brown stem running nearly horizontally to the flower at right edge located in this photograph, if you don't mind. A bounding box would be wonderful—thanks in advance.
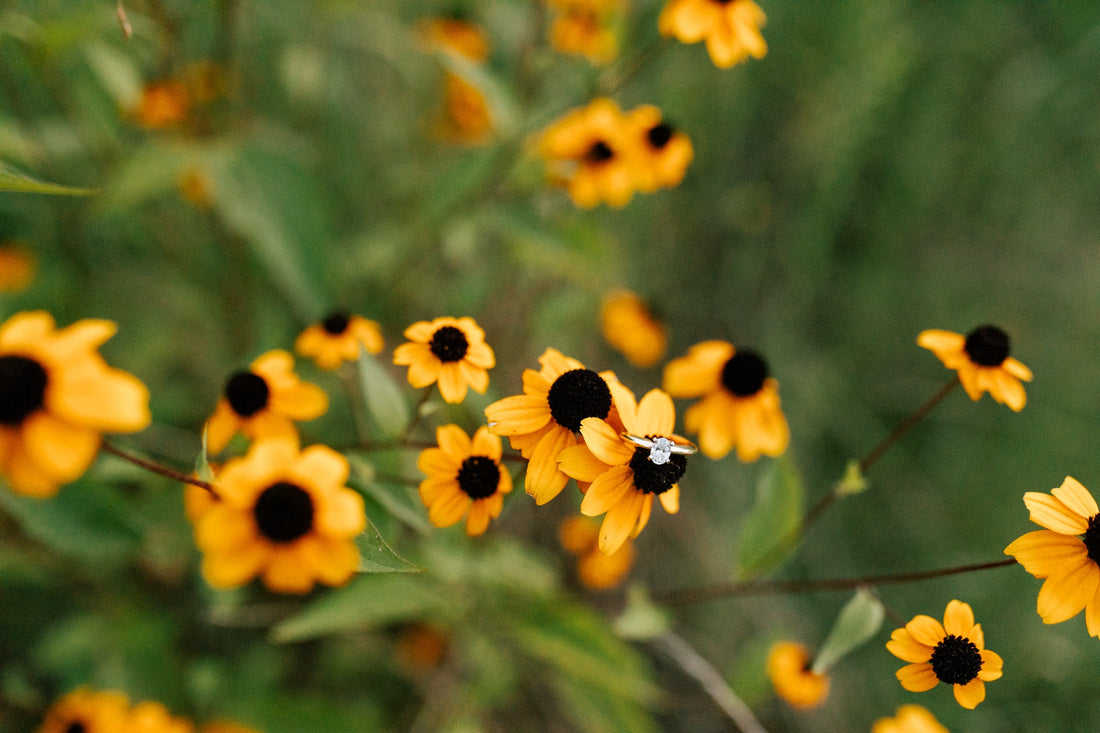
[653,558,1016,605]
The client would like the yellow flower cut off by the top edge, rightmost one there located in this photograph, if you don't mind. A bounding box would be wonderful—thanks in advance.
[657,0,768,68]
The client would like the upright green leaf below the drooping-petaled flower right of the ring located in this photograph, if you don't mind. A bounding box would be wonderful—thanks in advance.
[737,455,805,578]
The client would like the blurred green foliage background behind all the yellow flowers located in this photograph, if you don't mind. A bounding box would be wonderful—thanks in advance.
[0,0,1100,732]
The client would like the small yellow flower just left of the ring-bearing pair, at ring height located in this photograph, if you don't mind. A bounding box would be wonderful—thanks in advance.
[416,425,512,537]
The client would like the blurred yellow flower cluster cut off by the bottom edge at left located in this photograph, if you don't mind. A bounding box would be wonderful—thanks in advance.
[36,687,259,733]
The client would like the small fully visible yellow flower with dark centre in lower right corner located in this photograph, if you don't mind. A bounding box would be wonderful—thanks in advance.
[887,601,1003,710]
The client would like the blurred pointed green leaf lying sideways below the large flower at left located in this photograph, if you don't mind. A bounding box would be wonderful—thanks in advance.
[272,573,450,643]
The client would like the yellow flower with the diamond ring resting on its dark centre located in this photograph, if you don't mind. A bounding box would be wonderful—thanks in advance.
[558,382,695,555]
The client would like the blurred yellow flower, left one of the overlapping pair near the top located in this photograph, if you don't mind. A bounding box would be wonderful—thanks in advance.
[539,97,637,209]
